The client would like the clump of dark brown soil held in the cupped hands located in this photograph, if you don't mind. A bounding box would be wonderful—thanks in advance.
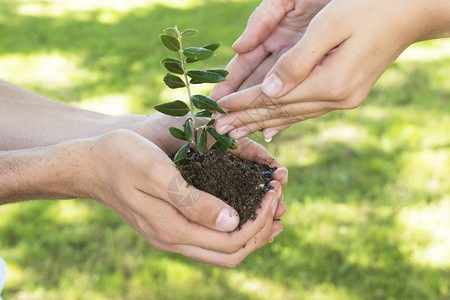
[178,150,276,229]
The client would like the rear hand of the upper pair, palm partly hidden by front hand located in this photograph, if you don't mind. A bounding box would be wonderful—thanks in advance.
[210,0,331,138]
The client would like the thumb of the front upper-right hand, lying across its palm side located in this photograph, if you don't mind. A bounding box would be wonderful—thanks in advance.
[261,15,346,98]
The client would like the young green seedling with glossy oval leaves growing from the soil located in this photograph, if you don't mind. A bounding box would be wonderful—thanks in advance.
[155,26,237,164]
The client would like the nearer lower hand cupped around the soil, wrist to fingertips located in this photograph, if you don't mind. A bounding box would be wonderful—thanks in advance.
[84,131,287,267]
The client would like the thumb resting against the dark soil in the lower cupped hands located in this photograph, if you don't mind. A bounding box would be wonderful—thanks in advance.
[168,174,243,232]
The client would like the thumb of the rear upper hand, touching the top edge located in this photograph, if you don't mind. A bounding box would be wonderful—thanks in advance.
[233,0,295,53]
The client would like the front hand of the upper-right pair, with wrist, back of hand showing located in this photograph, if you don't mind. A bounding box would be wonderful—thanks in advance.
[216,0,450,138]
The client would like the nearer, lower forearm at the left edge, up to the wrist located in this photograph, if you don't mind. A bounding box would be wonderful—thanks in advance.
[0,140,95,205]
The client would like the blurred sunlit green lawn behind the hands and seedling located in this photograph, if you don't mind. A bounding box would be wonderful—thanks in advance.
[0,0,450,300]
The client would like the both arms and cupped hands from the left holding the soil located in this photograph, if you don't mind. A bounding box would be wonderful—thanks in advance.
[0,82,287,268]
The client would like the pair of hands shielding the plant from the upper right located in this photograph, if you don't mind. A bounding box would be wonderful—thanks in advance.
[211,0,450,139]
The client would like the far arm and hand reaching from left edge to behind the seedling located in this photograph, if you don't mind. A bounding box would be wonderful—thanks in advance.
[0,80,183,150]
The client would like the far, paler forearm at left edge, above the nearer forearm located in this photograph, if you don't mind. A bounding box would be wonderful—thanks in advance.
[0,81,118,150]
